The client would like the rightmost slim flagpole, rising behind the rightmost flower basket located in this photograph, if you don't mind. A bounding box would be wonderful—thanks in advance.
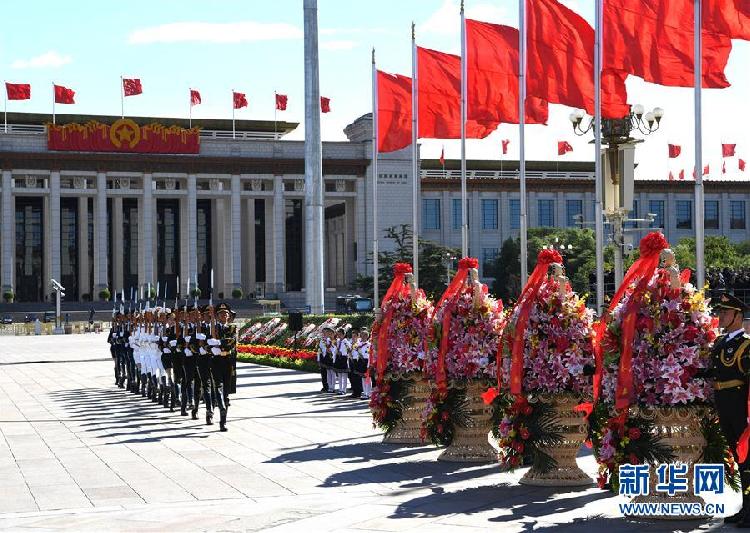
[693,0,706,289]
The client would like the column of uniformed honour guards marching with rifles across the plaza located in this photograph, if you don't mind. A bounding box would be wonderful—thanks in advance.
[107,303,237,431]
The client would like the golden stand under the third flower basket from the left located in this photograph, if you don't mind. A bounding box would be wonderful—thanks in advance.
[519,393,593,487]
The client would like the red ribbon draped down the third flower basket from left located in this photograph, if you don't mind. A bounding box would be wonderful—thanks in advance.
[508,248,562,396]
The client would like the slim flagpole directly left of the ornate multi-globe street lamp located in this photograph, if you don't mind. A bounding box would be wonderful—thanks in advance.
[594,0,604,313]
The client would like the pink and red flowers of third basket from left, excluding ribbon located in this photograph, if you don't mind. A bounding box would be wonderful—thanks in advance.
[501,277,594,396]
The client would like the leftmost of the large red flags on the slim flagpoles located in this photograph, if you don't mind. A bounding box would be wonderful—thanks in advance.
[378,71,411,153]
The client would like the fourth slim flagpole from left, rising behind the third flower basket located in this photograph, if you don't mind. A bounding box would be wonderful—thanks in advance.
[518,0,529,286]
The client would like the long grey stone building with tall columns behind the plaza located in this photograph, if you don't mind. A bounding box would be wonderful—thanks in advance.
[0,114,750,306]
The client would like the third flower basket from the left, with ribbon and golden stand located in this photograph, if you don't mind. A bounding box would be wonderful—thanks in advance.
[499,249,594,486]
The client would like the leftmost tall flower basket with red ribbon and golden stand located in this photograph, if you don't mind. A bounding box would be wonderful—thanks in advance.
[370,263,432,446]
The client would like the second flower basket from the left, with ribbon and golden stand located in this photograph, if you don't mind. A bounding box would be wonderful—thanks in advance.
[423,258,504,463]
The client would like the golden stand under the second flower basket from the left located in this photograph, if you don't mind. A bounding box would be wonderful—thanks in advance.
[438,380,498,463]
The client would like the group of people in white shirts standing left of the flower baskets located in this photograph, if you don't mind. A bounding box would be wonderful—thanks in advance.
[317,328,372,400]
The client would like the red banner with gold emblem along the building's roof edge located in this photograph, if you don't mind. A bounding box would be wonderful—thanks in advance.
[47,118,200,154]
